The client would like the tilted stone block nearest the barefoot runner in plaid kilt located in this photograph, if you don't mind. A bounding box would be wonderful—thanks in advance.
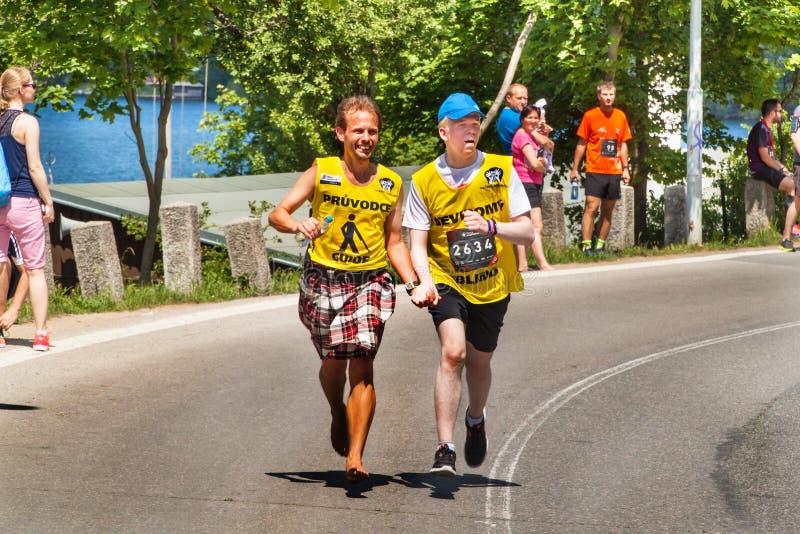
[223,217,270,291]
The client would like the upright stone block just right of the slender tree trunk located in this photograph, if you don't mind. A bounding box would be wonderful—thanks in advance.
[159,202,202,293]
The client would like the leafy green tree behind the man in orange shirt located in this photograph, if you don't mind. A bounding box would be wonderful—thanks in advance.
[518,0,800,245]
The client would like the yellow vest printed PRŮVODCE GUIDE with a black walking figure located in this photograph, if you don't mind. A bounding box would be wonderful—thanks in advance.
[309,157,403,271]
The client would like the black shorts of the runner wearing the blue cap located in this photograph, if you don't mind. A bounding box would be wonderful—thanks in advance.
[428,284,511,352]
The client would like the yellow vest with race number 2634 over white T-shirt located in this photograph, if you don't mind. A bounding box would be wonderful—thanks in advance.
[412,154,525,304]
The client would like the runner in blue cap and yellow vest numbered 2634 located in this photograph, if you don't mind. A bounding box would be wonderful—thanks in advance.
[403,93,534,476]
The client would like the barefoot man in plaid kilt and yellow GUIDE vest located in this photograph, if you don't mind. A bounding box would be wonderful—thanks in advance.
[269,96,435,482]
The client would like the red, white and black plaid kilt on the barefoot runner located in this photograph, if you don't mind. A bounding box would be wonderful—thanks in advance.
[298,264,396,360]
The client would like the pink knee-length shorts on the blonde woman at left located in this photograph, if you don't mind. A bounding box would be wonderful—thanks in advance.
[0,197,45,269]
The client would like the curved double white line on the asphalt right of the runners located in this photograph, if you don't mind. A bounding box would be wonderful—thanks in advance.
[485,321,800,533]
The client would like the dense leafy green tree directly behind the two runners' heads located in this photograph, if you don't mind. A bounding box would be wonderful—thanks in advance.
[205,0,518,173]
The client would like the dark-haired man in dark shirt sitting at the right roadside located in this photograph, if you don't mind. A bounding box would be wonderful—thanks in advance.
[747,98,798,252]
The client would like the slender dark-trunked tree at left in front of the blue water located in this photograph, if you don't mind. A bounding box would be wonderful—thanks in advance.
[0,0,215,283]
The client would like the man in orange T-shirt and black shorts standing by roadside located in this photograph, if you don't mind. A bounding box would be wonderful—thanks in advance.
[569,82,633,255]
